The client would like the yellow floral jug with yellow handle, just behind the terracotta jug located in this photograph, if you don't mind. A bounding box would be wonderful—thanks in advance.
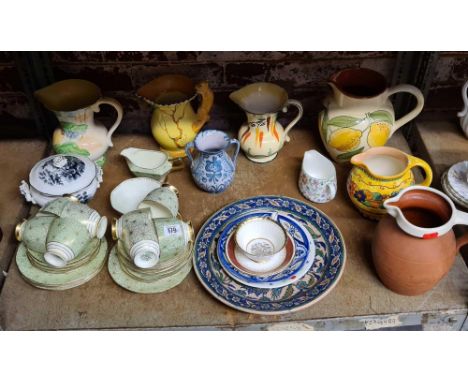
[346,147,432,220]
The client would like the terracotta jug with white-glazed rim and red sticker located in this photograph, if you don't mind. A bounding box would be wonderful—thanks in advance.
[372,187,468,296]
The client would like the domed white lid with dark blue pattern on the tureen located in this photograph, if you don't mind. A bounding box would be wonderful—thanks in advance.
[29,154,97,196]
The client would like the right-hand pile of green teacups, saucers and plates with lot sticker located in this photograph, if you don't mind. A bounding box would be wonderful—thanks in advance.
[109,184,193,293]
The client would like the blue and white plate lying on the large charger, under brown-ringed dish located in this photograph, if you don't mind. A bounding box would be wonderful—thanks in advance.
[217,209,315,288]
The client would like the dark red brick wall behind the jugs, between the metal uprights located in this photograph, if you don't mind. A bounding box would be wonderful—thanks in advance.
[51,52,396,132]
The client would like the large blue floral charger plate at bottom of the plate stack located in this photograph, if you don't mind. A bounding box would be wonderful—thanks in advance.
[193,196,346,314]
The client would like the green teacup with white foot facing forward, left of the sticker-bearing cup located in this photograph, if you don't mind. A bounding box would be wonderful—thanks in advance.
[112,208,160,268]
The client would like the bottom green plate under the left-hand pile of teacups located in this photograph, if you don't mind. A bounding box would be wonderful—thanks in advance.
[16,239,107,290]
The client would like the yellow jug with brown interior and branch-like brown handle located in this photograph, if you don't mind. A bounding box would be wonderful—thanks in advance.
[137,74,214,158]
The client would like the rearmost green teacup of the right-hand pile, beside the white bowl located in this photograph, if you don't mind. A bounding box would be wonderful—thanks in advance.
[138,183,179,219]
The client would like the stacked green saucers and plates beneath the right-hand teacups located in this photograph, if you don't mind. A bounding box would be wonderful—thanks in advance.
[108,240,193,293]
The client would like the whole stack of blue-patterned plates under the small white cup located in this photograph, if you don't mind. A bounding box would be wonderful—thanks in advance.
[193,196,346,314]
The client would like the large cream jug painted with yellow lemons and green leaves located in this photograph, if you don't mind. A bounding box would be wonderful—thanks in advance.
[319,68,424,162]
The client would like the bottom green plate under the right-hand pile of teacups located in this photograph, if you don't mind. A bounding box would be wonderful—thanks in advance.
[107,246,192,293]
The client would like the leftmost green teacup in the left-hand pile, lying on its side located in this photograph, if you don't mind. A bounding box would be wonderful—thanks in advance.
[15,215,57,253]
